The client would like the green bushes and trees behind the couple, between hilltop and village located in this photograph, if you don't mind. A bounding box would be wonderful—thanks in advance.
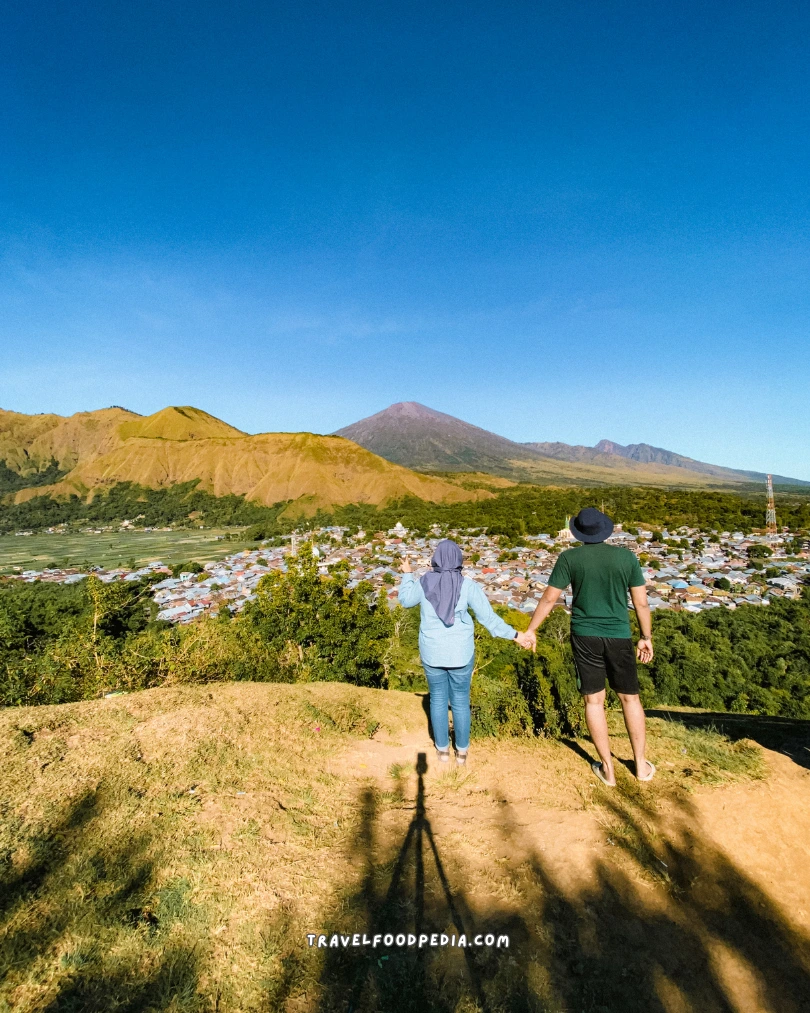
[0,550,810,736]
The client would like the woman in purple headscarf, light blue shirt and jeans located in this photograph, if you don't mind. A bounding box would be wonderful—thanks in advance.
[399,538,530,764]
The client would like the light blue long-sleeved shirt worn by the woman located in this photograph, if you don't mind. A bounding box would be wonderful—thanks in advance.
[399,573,516,669]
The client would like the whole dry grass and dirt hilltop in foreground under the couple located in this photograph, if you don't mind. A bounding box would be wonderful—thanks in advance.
[0,684,810,1013]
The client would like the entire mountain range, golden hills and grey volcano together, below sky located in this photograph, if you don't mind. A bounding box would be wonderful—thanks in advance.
[0,401,810,516]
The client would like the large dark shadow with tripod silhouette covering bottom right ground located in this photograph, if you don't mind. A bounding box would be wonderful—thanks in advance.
[267,754,810,1013]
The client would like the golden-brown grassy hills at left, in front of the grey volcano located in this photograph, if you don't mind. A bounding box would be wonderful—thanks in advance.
[0,406,493,513]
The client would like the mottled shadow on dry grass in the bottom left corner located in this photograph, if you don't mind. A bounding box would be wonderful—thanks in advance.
[0,790,211,1013]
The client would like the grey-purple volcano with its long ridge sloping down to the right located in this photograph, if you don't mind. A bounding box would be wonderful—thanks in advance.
[336,401,810,487]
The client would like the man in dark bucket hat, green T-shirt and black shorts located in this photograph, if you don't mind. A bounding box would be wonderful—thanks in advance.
[527,507,655,787]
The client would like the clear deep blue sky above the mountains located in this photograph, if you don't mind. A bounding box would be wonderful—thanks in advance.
[0,0,810,479]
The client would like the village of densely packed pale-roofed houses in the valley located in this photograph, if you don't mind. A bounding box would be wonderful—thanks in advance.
[11,523,810,624]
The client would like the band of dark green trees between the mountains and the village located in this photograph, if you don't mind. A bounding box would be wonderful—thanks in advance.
[0,476,810,539]
